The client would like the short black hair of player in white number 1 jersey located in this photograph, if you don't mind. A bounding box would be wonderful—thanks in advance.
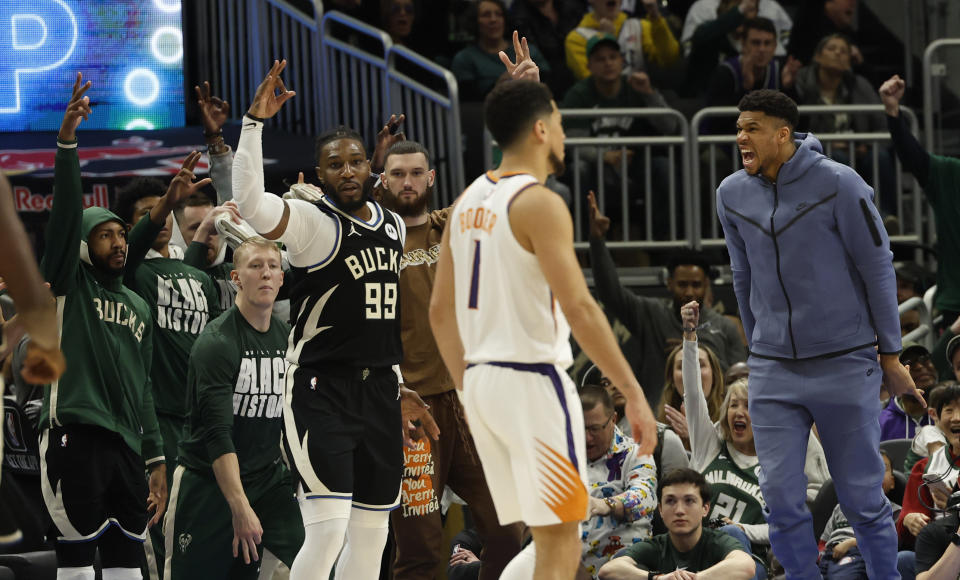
[483,80,553,149]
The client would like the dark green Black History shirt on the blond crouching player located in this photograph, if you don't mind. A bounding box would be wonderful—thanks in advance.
[179,306,290,479]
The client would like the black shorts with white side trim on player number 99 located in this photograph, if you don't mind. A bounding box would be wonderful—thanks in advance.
[283,365,403,510]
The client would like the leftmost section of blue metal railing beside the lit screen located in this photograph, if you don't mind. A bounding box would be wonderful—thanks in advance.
[193,0,321,134]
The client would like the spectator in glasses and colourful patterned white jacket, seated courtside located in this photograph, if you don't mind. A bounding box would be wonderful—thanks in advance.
[580,385,657,576]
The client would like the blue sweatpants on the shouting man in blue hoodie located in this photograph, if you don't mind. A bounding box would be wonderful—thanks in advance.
[748,347,900,580]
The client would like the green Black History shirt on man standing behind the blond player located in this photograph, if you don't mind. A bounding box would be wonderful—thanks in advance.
[124,215,220,417]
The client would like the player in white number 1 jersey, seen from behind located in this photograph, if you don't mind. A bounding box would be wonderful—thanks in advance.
[430,80,657,580]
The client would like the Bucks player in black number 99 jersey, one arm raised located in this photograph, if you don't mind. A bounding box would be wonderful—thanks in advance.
[233,61,435,580]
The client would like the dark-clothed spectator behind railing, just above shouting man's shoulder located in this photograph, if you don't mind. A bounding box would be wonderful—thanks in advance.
[793,34,899,216]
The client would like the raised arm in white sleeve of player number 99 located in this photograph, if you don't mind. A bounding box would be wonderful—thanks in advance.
[232,60,296,240]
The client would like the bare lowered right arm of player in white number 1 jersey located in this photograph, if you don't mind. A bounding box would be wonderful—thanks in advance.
[510,185,657,454]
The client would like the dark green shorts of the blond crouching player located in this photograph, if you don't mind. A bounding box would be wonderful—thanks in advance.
[163,465,303,580]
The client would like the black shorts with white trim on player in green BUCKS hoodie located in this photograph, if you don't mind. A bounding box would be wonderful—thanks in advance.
[40,424,147,542]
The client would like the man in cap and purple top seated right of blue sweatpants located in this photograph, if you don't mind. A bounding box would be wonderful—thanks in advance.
[880,342,937,441]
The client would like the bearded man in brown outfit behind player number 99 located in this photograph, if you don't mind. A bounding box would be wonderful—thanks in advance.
[379,141,522,580]
